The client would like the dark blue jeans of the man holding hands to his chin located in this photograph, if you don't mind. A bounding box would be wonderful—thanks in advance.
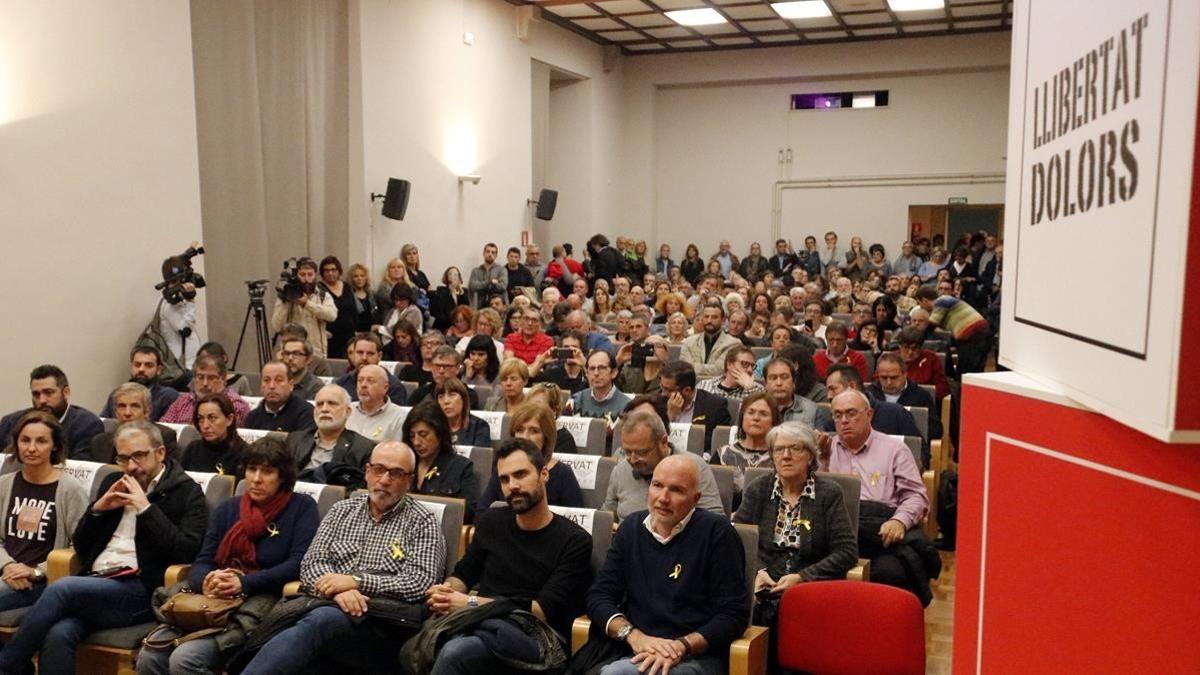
[0,577,154,675]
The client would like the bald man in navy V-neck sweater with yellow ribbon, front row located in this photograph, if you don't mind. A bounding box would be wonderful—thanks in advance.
[587,455,750,675]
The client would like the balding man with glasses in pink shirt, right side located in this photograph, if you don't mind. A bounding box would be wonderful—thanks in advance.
[821,389,940,605]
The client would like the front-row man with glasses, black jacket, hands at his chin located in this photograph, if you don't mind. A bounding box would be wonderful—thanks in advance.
[0,420,209,673]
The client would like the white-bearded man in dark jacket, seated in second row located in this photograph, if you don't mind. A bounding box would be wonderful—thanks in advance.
[287,384,374,473]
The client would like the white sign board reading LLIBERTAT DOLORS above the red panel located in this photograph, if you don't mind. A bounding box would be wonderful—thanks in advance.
[1000,0,1200,442]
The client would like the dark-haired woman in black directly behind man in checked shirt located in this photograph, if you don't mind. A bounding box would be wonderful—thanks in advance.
[402,401,477,522]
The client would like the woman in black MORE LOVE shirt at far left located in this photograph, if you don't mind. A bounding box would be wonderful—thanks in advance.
[0,410,89,611]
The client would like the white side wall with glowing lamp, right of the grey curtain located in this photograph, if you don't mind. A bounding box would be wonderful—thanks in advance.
[350,0,622,278]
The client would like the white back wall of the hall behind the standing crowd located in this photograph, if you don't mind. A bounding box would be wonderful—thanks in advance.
[622,34,1009,256]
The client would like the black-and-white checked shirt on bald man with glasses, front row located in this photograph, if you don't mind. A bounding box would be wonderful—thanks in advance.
[300,487,446,602]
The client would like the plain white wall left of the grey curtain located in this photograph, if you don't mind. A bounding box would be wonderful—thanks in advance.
[0,0,204,412]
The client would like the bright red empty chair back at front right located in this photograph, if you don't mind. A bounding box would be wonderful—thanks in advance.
[775,580,925,675]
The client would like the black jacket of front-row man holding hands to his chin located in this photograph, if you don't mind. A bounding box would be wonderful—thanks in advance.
[74,458,209,597]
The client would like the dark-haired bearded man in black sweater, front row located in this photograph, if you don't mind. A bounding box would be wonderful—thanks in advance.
[426,438,592,675]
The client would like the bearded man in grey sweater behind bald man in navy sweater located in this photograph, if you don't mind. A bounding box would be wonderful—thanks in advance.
[601,396,725,520]
